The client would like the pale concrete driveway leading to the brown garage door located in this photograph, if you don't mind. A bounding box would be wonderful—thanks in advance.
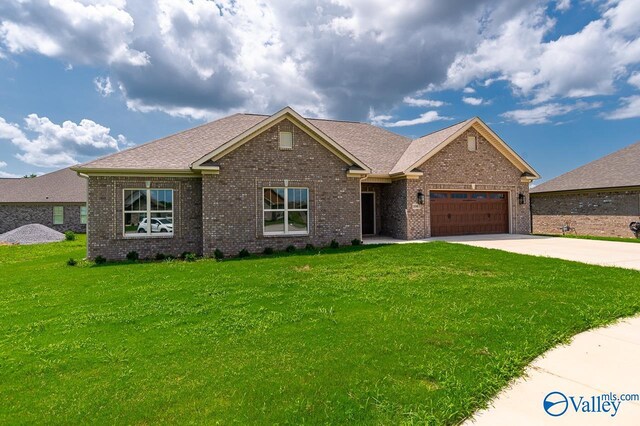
[432,234,640,270]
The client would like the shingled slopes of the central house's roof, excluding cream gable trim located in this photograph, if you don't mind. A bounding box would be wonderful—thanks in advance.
[79,111,536,175]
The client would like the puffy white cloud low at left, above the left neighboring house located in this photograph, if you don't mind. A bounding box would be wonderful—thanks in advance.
[0,114,128,167]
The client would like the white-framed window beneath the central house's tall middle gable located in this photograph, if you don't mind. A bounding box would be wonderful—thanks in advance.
[263,188,309,235]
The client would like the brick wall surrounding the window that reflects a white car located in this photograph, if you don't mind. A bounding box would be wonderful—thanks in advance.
[87,176,202,259]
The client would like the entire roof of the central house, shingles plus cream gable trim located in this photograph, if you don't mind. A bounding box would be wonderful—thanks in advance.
[74,107,539,179]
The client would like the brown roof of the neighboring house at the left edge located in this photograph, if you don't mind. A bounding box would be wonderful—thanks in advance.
[0,168,87,203]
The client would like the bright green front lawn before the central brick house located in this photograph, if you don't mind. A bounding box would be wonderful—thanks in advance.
[0,236,640,424]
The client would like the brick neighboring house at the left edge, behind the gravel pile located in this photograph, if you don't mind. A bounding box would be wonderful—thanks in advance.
[0,169,87,234]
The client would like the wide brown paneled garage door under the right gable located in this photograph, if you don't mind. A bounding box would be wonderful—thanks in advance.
[430,191,509,237]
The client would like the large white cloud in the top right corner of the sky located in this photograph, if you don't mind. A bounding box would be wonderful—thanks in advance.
[443,0,640,103]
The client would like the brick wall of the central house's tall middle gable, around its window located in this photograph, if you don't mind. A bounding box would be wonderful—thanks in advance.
[202,120,361,256]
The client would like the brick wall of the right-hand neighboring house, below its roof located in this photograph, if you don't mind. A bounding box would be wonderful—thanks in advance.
[531,191,640,238]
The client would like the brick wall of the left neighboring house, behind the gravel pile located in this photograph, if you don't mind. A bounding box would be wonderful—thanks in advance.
[0,203,87,234]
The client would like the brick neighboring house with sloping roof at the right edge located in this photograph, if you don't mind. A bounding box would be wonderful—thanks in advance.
[531,142,640,237]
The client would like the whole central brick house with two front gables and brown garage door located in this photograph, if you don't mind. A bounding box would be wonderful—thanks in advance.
[74,107,538,259]
